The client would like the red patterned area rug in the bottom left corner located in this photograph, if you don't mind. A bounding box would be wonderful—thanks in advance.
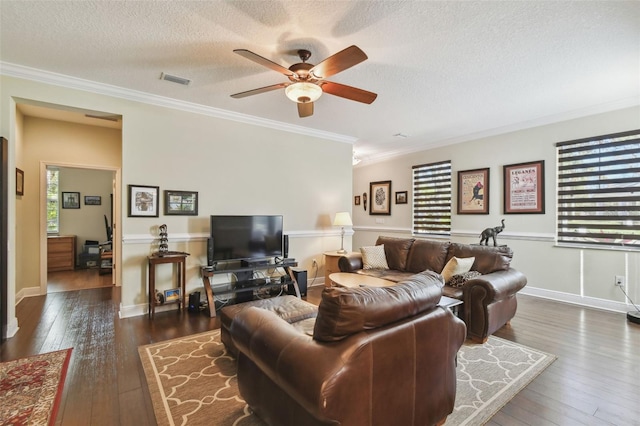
[0,349,71,426]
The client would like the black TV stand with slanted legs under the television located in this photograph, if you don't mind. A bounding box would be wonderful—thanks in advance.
[200,259,302,318]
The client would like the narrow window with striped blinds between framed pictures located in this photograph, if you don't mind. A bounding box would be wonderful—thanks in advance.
[413,161,451,236]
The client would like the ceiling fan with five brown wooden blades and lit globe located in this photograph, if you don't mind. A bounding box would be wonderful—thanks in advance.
[231,46,378,117]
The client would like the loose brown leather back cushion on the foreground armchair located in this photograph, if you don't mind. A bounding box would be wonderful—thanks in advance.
[313,271,443,342]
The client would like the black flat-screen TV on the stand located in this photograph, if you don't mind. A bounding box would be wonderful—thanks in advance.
[211,215,282,261]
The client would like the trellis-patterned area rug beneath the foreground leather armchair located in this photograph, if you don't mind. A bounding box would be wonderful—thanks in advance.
[138,330,555,426]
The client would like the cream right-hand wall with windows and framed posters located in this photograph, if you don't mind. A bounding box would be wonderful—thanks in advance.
[353,107,640,311]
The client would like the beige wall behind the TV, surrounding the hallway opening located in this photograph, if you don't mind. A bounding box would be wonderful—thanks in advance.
[0,76,352,324]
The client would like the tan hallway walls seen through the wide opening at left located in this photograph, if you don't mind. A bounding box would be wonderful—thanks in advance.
[16,100,122,296]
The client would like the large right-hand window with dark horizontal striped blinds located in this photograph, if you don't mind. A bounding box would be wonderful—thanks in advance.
[556,130,640,248]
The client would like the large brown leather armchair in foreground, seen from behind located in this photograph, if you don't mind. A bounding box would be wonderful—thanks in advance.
[230,272,465,426]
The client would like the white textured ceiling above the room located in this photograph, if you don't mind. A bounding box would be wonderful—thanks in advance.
[0,0,640,163]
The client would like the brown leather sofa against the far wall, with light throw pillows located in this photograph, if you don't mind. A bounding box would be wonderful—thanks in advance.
[338,236,527,342]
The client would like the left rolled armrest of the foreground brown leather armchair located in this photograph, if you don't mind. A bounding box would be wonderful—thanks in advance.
[231,307,358,418]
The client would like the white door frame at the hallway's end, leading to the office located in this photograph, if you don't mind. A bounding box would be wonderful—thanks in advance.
[39,161,122,294]
